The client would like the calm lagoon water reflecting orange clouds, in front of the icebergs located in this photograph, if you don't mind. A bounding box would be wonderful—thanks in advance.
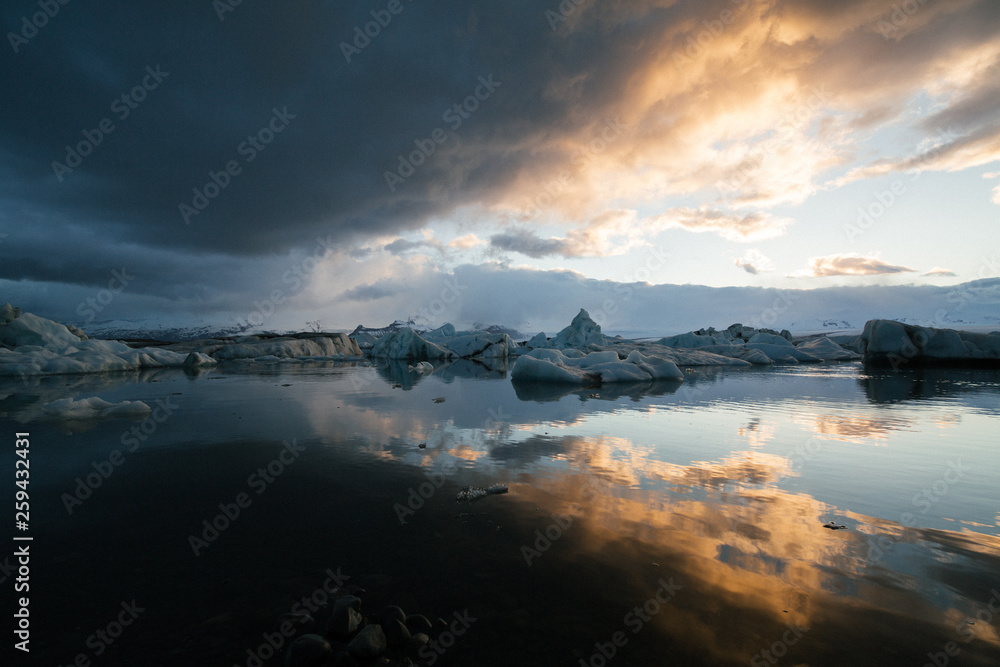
[0,363,1000,667]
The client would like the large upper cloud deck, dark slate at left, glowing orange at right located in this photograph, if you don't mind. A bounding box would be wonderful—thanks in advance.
[0,0,1000,326]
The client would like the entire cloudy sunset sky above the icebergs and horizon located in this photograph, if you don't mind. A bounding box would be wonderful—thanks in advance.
[0,0,1000,332]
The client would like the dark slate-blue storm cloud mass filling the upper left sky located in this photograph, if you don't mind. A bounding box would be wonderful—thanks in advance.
[0,1,584,280]
